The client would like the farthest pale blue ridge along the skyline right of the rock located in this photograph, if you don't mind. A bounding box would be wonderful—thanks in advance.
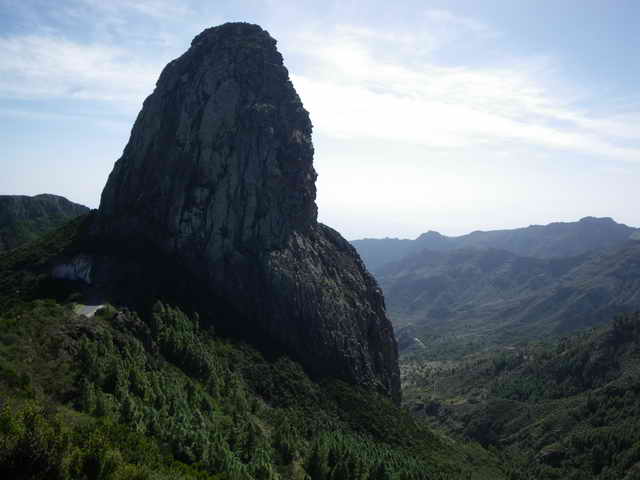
[351,217,639,273]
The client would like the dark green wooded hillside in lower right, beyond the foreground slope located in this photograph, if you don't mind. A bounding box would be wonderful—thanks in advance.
[403,313,640,480]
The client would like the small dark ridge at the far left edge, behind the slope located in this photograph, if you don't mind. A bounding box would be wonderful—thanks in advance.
[0,193,89,251]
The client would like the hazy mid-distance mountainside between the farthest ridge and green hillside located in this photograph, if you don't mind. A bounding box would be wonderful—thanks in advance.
[377,242,640,354]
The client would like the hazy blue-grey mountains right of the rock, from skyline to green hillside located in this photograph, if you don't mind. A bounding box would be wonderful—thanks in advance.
[353,217,640,347]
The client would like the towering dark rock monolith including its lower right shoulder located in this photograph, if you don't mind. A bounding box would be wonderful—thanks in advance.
[97,23,400,400]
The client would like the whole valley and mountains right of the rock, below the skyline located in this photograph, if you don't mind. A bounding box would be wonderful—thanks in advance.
[353,218,640,479]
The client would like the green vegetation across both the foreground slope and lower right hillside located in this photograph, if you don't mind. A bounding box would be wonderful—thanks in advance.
[11,216,640,480]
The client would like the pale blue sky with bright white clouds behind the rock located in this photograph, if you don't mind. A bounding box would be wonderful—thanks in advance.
[0,0,640,239]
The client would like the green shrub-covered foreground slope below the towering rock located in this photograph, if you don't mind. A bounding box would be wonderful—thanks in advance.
[0,217,503,480]
